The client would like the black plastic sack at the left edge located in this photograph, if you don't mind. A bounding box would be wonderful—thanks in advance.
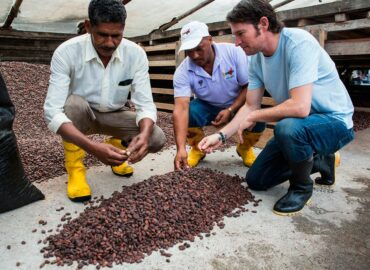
[0,73,45,213]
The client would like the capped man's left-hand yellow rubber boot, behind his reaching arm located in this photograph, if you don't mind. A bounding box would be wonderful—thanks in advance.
[187,127,206,167]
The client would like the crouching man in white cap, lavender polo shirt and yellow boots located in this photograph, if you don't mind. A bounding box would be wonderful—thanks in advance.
[173,21,265,169]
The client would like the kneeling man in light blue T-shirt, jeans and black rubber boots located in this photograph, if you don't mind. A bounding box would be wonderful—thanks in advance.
[200,0,354,215]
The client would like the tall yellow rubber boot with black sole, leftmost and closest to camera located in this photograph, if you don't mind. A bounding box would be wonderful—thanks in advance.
[63,141,91,202]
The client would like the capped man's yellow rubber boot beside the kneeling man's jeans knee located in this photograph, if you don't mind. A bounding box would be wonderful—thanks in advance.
[236,131,262,167]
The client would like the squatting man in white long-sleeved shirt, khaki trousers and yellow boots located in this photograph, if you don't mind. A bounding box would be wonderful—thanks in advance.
[44,0,165,201]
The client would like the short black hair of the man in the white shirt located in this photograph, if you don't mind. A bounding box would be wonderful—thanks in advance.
[89,0,127,25]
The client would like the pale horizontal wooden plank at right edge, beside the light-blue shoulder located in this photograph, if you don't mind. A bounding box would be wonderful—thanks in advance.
[325,38,370,56]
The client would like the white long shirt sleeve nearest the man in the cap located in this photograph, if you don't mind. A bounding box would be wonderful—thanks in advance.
[131,50,157,125]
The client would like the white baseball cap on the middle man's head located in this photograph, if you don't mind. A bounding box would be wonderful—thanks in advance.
[179,21,209,51]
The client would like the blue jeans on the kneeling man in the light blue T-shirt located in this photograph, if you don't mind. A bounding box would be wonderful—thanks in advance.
[246,114,354,190]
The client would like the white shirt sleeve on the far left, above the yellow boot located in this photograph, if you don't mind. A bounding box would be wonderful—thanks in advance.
[44,49,71,133]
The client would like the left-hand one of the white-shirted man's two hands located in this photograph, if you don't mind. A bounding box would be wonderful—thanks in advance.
[91,143,129,166]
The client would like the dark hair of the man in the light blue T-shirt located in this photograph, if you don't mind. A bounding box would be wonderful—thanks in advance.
[226,0,284,33]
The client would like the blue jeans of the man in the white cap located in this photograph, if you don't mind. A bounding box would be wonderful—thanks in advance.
[189,99,266,132]
